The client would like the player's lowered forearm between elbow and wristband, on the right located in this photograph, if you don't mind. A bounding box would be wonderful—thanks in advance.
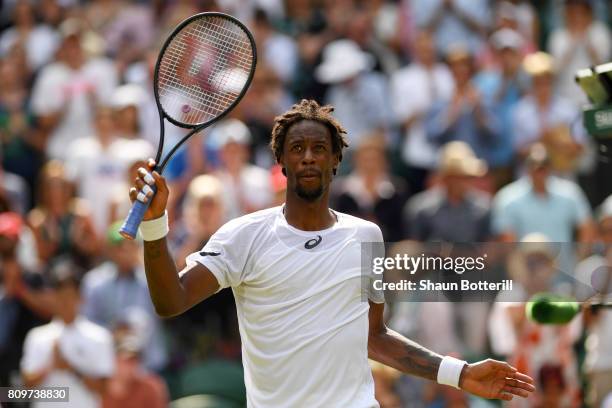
[368,328,442,381]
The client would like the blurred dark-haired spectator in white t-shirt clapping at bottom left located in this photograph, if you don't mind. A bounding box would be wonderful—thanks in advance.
[21,258,115,408]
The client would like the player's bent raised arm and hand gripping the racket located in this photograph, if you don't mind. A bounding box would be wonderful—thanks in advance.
[130,160,219,317]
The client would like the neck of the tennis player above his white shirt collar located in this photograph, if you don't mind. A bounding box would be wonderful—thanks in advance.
[285,192,336,231]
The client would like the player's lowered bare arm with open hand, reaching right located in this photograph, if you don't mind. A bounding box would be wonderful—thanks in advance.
[368,302,535,401]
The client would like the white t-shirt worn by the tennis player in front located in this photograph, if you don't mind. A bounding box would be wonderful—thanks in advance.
[187,207,384,408]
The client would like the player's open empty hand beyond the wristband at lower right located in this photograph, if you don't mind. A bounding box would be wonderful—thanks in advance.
[459,359,535,401]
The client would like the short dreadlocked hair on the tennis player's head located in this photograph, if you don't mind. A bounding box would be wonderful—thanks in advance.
[270,99,348,174]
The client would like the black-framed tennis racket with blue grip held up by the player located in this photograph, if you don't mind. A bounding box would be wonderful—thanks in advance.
[119,12,257,239]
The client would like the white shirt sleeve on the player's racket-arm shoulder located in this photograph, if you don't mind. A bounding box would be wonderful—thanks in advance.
[186,218,252,290]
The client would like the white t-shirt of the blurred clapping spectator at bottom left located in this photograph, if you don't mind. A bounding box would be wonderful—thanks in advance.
[21,317,115,408]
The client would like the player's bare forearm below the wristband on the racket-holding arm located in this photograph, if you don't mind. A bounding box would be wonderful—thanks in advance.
[144,238,186,317]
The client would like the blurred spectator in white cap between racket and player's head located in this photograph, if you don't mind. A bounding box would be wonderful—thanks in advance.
[211,119,272,220]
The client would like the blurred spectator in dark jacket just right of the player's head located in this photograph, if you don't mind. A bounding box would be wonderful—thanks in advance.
[334,134,408,242]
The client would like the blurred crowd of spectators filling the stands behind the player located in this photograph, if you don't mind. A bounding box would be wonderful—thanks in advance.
[0,0,612,408]
